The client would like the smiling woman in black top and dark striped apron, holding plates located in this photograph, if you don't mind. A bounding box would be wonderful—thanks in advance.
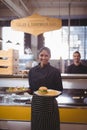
[28,47,63,130]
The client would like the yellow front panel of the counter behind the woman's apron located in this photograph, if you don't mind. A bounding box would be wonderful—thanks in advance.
[0,101,87,124]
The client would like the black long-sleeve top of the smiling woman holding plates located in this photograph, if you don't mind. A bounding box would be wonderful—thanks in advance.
[28,63,63,92]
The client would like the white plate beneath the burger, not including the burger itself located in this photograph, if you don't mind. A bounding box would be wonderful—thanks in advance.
[34,89,61,97]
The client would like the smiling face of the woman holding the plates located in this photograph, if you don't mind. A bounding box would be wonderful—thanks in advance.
[39,50,50,66]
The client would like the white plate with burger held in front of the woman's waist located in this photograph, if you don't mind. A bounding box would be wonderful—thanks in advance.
[34,86,62,97]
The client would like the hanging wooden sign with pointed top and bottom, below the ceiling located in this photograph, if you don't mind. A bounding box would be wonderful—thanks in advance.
[11,14,62,36]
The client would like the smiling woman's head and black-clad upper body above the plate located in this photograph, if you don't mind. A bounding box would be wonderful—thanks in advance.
[29,47,63,92]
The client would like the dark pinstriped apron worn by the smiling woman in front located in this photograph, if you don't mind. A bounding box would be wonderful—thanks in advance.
[31,94,60,130]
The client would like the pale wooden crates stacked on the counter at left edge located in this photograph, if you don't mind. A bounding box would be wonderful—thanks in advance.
[0,49,19,75]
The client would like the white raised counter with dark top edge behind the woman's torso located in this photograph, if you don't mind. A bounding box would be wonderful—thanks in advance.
[0,74,87,89]
